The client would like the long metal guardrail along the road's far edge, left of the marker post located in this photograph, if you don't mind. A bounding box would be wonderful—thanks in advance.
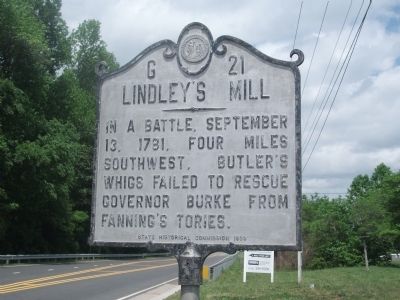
[0,252,171,265]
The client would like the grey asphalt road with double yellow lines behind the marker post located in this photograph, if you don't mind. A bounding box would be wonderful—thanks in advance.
[0,255,222,300]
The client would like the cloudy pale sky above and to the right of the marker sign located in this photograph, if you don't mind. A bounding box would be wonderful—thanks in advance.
[62,0,400,197]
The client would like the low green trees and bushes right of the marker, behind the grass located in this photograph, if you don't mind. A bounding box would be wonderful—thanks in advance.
[302,164,400,268]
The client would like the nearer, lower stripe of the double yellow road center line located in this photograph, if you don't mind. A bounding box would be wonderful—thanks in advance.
[0,262,176,294]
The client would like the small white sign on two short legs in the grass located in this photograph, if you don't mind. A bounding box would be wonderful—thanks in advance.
[243,251,274,283]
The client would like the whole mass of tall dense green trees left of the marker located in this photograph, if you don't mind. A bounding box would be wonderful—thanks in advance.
[0,0,118,253]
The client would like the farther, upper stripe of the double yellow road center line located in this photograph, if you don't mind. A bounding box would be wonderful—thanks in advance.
[0,259,176,293]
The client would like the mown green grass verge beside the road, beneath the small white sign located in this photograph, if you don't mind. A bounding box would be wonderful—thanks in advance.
[167,257,400,300]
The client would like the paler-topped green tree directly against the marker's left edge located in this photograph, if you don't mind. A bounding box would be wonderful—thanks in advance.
[65,20,118,247]
